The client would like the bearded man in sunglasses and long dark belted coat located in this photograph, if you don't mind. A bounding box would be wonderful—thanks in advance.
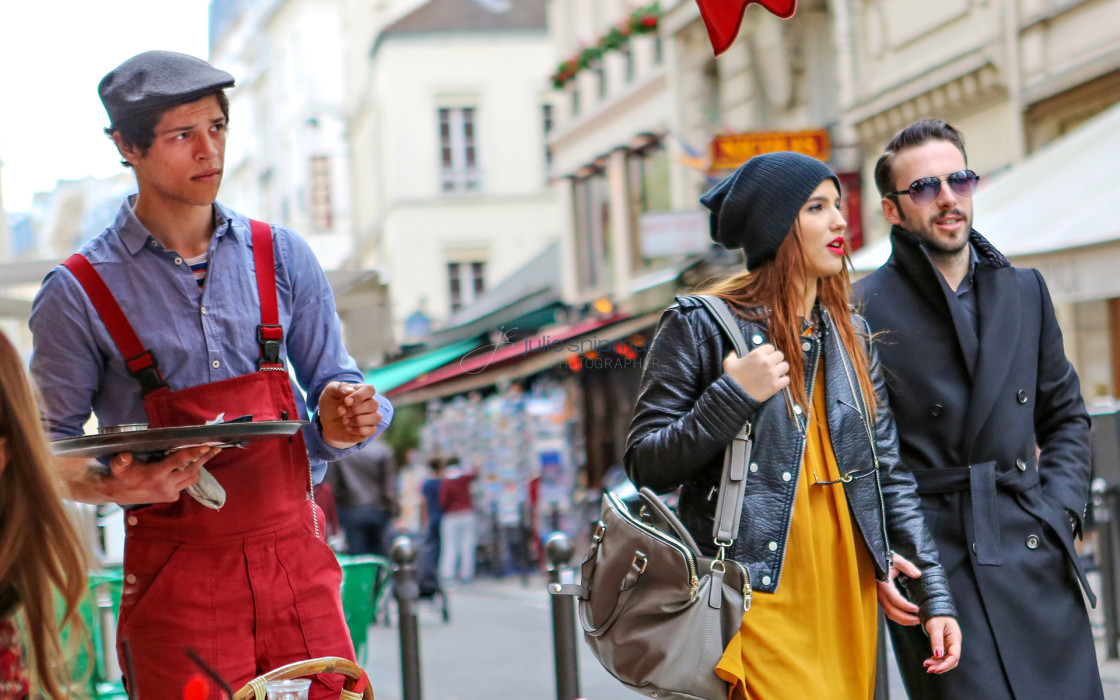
[856,119,1102,700]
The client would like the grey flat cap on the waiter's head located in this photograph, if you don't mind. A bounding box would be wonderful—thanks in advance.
[97,52,233,127]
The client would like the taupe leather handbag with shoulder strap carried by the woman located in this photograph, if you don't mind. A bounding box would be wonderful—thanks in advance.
[551,296,752,700]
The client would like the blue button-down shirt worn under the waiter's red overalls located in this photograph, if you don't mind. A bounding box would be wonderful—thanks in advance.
[30,198,393,483]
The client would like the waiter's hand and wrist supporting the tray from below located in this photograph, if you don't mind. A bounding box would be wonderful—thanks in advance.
[60,447,222,505]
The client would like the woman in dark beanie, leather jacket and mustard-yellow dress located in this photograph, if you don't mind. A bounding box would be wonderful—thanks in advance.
[625,152,961,700]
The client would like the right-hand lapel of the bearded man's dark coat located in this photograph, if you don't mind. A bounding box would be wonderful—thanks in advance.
[962,265,1020,458]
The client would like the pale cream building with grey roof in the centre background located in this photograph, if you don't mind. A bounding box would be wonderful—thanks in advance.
[348,0,560,345]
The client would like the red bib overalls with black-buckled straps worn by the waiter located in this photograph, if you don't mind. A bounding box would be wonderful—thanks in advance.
[64,222,354,700]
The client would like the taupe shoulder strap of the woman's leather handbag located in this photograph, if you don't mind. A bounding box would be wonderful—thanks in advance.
[693,295,753,551]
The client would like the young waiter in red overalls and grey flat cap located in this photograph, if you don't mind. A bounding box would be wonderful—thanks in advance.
[30,52,392,698]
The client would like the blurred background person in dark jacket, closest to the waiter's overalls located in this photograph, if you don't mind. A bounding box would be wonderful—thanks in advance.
[328,440,401,557]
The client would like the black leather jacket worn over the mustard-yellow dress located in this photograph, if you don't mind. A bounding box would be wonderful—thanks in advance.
[625,297,956,622]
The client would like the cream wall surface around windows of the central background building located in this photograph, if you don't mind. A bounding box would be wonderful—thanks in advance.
[351,31,560,332]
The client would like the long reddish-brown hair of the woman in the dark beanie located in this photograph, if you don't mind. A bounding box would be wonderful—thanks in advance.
[698,221,876,420]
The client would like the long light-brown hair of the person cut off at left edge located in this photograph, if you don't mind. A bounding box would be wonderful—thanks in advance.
[0,333,87,698]
